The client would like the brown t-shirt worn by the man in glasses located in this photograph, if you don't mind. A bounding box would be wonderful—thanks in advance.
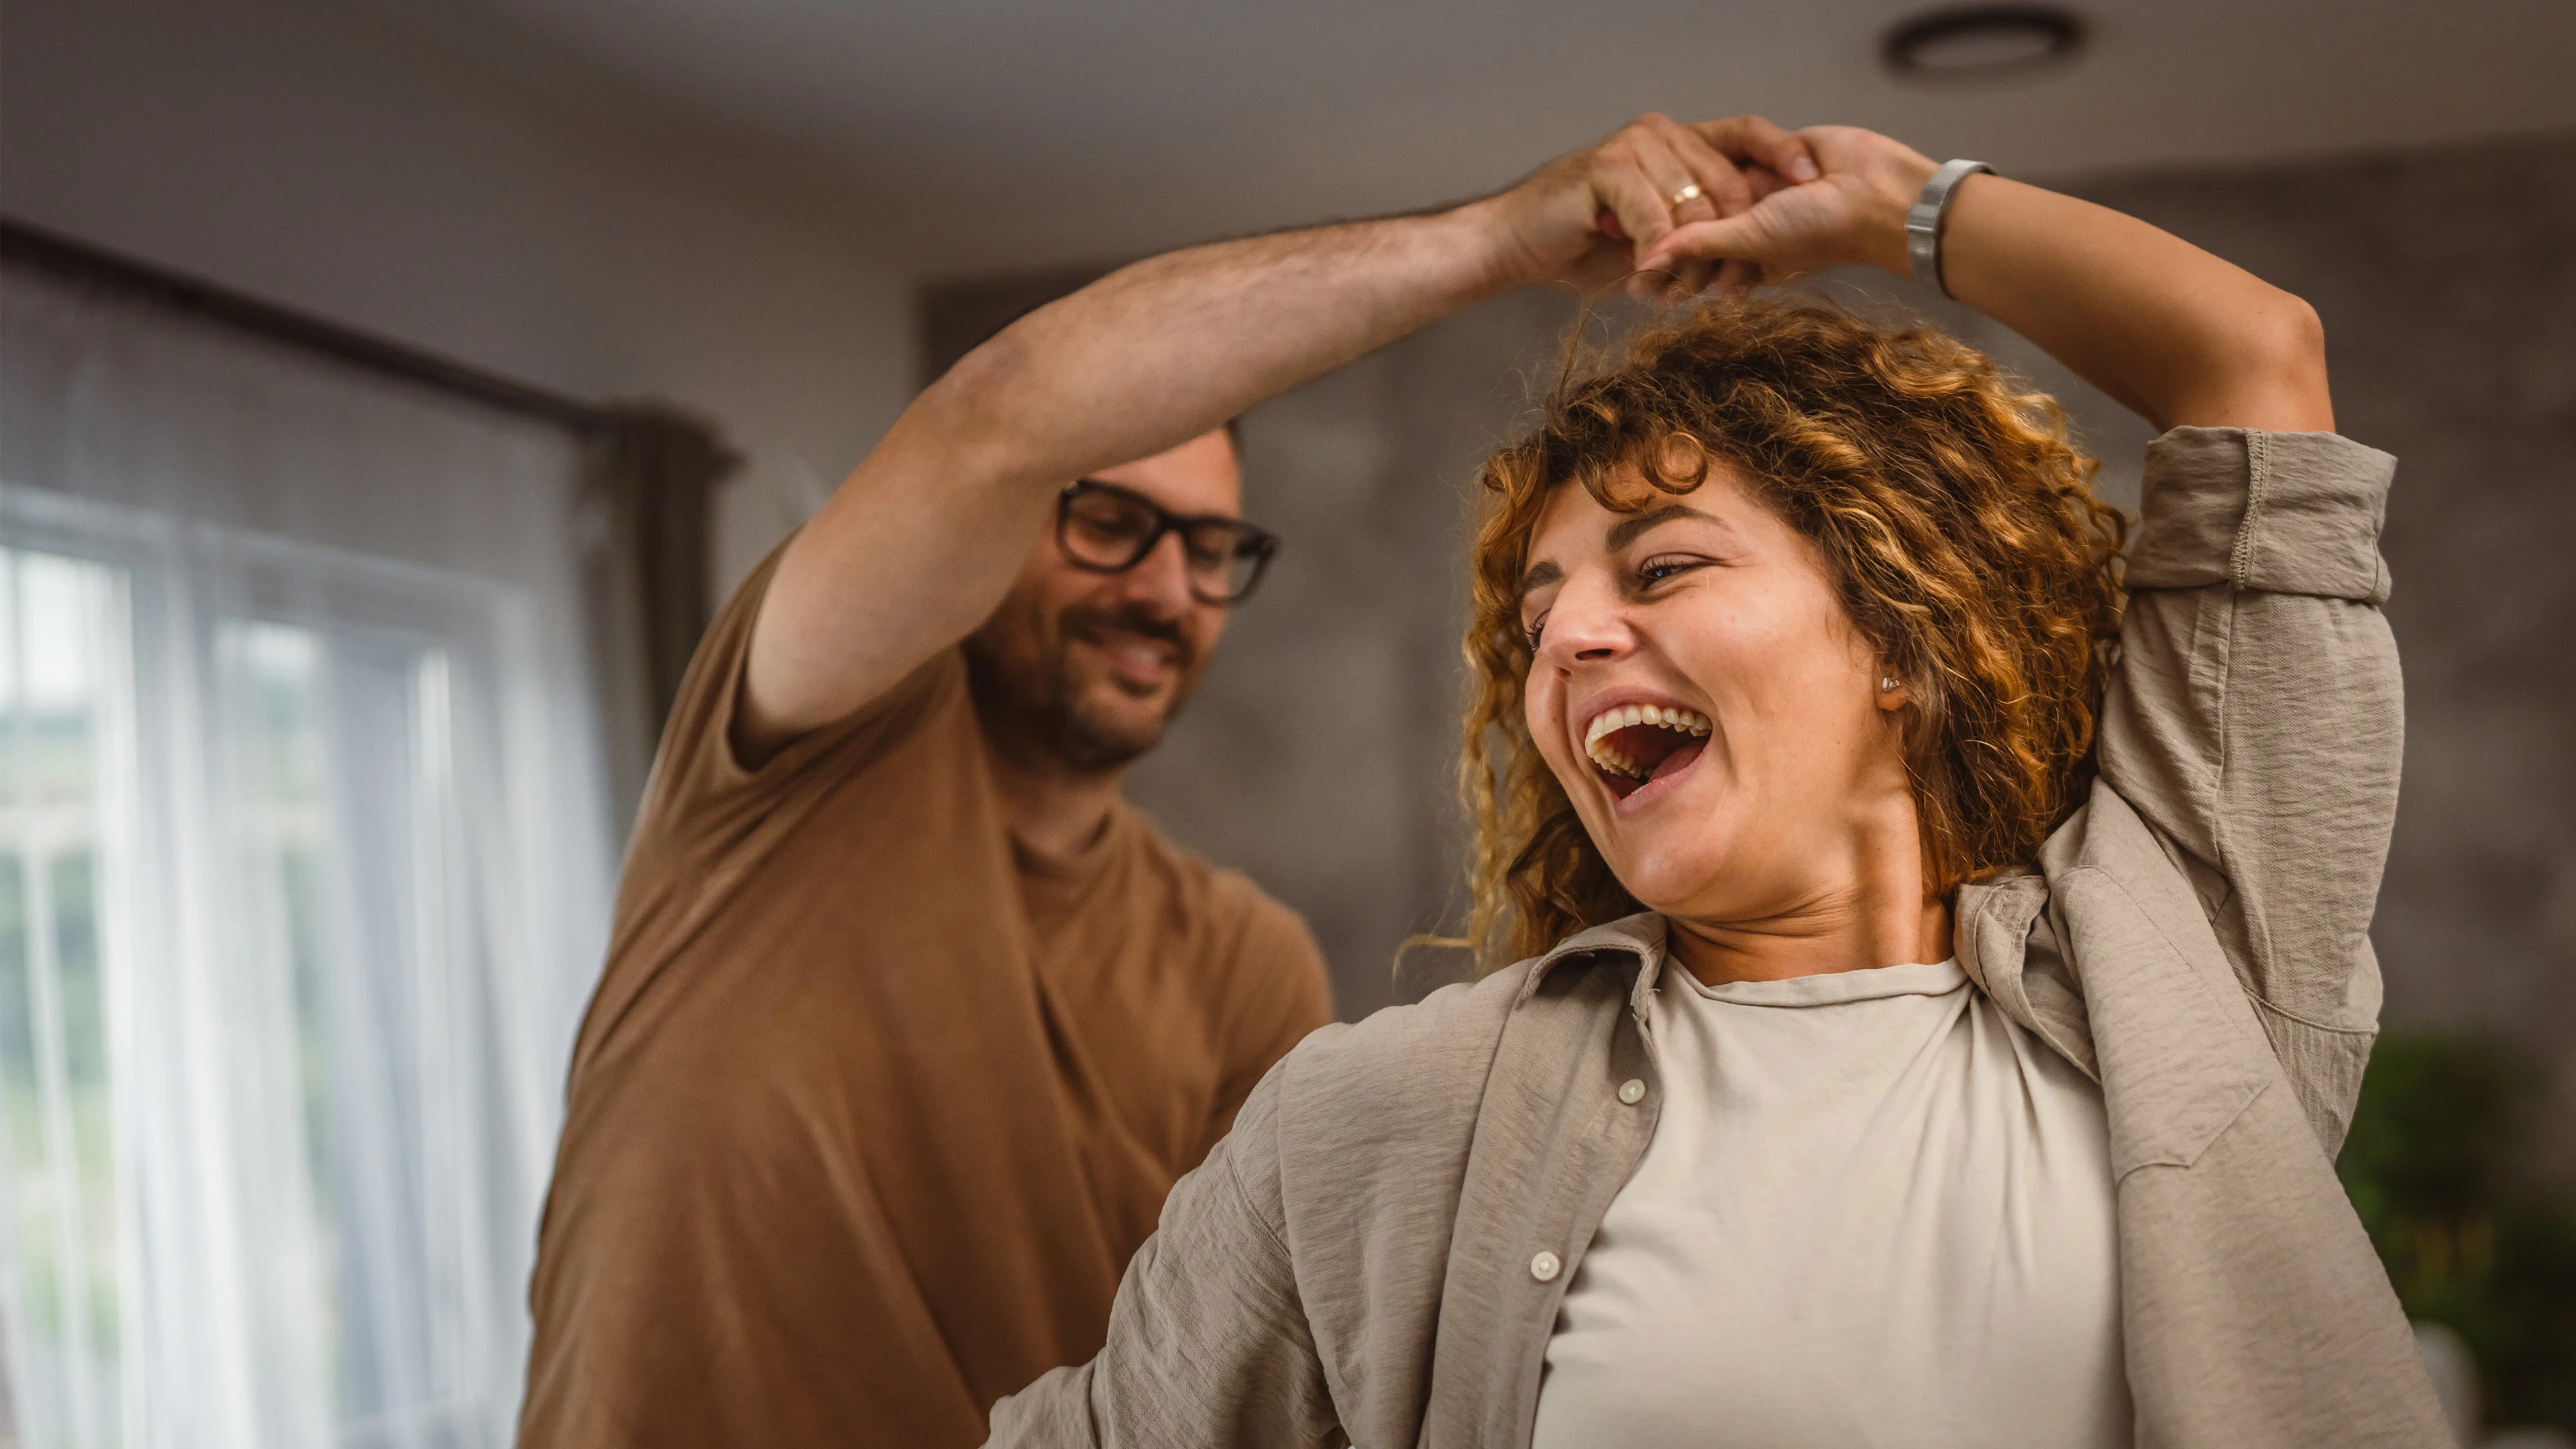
[521,554,1332,1449]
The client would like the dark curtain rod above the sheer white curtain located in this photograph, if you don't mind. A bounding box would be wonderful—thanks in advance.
[0,217,608,433]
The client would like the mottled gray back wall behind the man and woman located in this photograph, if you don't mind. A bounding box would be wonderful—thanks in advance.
[937,137,2576,1122]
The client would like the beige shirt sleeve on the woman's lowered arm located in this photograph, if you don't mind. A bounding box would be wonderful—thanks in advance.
[989,1067,1347,1449]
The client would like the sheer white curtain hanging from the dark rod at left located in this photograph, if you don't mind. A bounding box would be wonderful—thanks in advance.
[0,268,613,1449]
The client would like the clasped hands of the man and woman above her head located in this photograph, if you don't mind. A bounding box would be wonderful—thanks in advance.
[1473,113,1935,299]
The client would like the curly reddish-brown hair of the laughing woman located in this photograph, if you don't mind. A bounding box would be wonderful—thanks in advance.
[1460,302,2128,967]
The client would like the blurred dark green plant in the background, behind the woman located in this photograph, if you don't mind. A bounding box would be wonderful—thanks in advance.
[2337,1031,2576,1434]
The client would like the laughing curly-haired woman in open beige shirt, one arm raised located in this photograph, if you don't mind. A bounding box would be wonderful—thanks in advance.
[994,129,2447,1446]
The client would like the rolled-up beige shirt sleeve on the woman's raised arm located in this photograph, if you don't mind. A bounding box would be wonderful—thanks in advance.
[2100,428,2404,1152]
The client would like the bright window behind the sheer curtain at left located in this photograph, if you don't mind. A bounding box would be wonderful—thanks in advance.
[0,511,569,1449]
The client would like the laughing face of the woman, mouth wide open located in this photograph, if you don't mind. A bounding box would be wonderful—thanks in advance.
[1520,464,1914,920]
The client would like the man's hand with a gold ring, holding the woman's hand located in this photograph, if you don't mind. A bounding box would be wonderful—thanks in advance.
[1484,113,1821,291]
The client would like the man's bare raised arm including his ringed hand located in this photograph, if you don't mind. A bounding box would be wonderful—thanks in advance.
[737,116,1813,750]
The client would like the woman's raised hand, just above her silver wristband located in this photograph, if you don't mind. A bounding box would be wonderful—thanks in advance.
[1635,116,1935,291]
